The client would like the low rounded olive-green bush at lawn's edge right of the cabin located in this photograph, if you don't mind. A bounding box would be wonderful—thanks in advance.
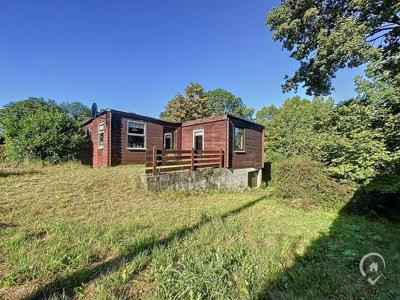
[272,156,350,209]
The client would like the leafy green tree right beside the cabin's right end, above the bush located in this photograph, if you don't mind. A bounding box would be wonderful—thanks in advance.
[258,96,333,161]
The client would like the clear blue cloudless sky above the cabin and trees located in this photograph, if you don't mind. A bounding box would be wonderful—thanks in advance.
[0,0,360,117]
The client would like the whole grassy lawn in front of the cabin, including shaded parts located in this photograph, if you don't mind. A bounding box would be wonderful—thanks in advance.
[0,164,400,299]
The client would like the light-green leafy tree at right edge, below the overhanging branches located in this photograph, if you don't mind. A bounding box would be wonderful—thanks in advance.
[322,64,400,184]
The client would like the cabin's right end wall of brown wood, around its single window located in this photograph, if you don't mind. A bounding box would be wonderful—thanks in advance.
[229,117,264,169]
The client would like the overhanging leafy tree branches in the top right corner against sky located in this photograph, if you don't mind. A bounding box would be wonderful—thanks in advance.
[266,0,400,95]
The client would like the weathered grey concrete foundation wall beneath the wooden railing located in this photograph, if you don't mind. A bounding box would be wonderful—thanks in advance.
[142,168,262,191]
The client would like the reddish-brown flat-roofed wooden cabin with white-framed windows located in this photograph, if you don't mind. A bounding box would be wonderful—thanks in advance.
[84,109,264,170]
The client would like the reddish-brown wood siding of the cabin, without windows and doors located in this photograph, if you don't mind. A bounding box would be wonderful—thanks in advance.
[85,110,264,169]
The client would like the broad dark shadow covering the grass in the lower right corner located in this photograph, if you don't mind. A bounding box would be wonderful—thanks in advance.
[256,176,400,299]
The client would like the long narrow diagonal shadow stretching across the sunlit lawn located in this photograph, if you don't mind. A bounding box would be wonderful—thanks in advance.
[26,196,265,299]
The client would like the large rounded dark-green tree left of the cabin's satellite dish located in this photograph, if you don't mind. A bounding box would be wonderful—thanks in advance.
[0,98,84,163]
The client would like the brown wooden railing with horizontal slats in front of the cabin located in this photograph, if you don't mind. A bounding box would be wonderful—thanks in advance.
[146,147,224,175]
